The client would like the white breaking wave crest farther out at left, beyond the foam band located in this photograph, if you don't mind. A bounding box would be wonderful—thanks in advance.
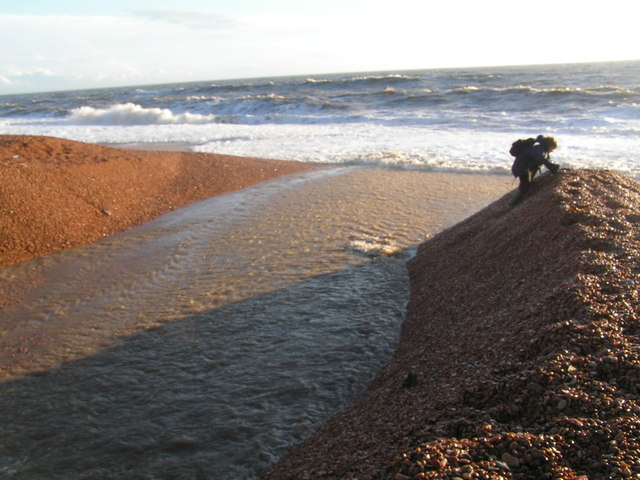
[67,102,216,125]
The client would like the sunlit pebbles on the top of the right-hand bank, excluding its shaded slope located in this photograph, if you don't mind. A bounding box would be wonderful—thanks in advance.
[344,175,640,480]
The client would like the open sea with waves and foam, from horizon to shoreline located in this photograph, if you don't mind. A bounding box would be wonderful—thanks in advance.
[0,61,640,176]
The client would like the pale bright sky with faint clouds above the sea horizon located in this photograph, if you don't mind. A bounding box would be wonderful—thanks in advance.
[0,0,640,95]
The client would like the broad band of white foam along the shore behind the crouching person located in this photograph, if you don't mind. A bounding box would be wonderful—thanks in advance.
[3,116,640,176]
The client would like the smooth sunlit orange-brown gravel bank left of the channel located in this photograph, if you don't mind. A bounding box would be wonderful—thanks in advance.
[0,135,313,274]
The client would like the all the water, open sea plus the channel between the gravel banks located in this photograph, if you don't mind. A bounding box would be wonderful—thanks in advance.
[0,62,640,480]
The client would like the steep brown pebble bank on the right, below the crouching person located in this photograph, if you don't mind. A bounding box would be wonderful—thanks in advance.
[264,170,640,480]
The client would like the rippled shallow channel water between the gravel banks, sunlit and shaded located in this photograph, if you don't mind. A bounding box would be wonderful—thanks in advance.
[0,168,512,479]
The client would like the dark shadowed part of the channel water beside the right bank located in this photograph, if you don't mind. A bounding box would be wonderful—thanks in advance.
[0,249,412,479]
